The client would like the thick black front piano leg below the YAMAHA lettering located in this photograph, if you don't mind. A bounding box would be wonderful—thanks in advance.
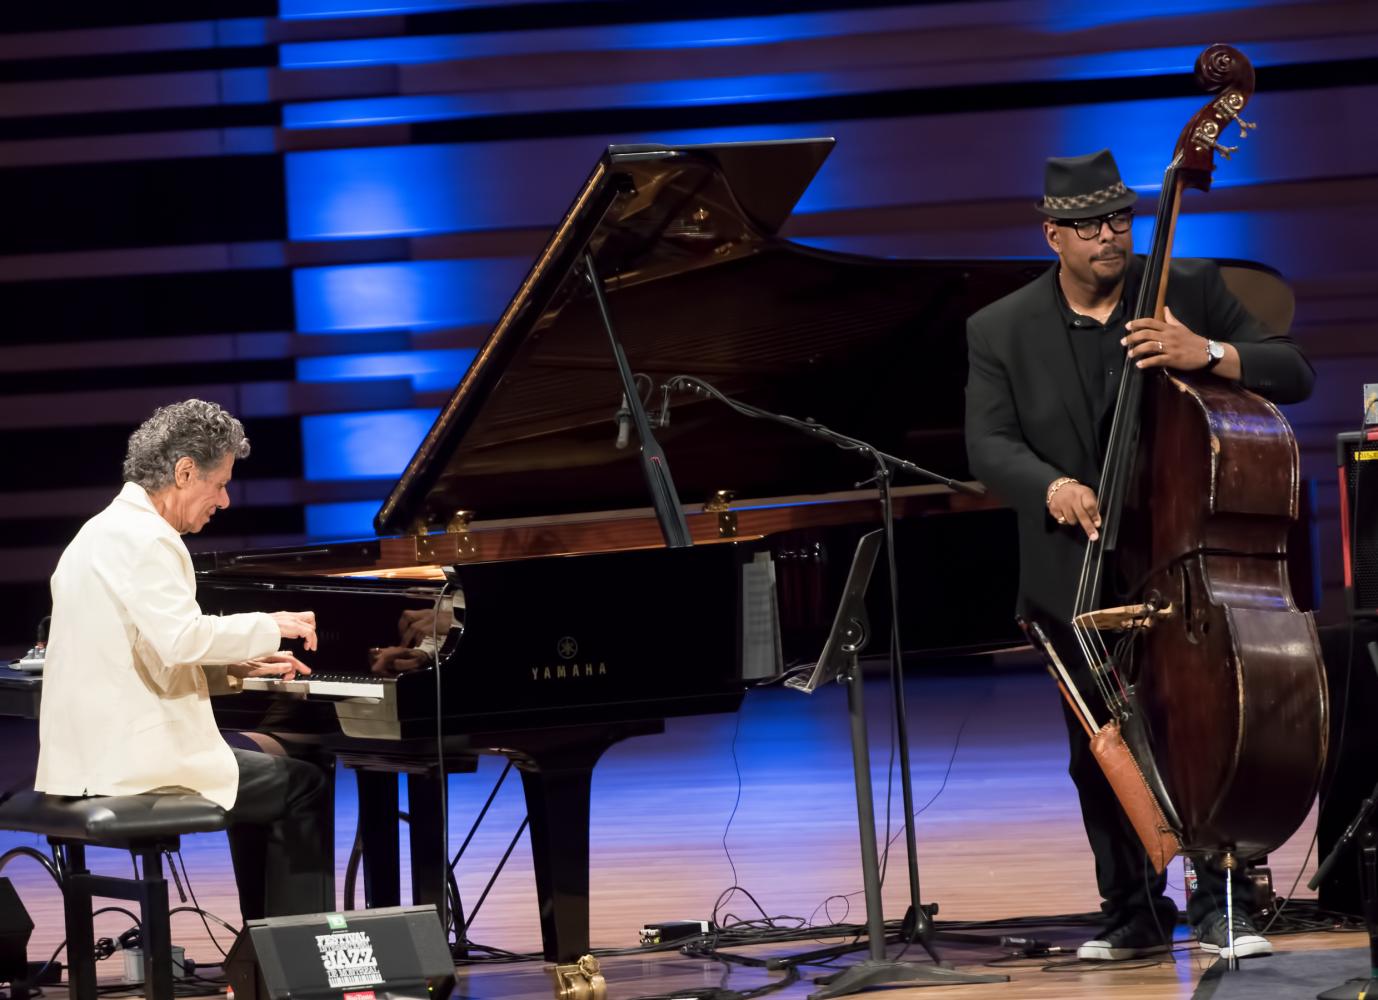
[507,720,664,963]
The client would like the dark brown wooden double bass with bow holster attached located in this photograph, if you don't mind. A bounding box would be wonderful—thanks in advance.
[1036,44,1327,871]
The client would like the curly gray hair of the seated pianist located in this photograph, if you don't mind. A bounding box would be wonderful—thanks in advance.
[124,399,249,493]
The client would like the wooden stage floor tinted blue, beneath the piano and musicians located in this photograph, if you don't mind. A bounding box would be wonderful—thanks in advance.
[0,658,1367,1000]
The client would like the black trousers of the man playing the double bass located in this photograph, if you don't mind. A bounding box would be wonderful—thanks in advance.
[1031,616,1254,933]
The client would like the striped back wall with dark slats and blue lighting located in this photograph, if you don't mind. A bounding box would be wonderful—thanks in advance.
[0,0,1378,646]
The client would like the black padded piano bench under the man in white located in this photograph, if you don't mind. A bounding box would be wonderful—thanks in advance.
[0,792,225,1000]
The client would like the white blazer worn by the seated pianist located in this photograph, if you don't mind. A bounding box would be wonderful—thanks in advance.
[33,482,278,809]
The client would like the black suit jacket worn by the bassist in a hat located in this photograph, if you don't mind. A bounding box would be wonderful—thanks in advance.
[966,258,1316,621]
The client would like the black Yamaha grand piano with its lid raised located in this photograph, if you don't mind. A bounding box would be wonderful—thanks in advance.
[197,139,1289,961]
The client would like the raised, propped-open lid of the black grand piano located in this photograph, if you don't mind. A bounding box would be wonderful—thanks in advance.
[373,139,1280,534]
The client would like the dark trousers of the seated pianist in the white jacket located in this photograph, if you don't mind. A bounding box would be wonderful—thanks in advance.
[227,747,335,920]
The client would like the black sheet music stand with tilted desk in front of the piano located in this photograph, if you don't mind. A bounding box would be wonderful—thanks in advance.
[785,529,1009,1000]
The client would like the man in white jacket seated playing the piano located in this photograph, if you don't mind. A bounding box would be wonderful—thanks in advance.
[34,399,335,920]
